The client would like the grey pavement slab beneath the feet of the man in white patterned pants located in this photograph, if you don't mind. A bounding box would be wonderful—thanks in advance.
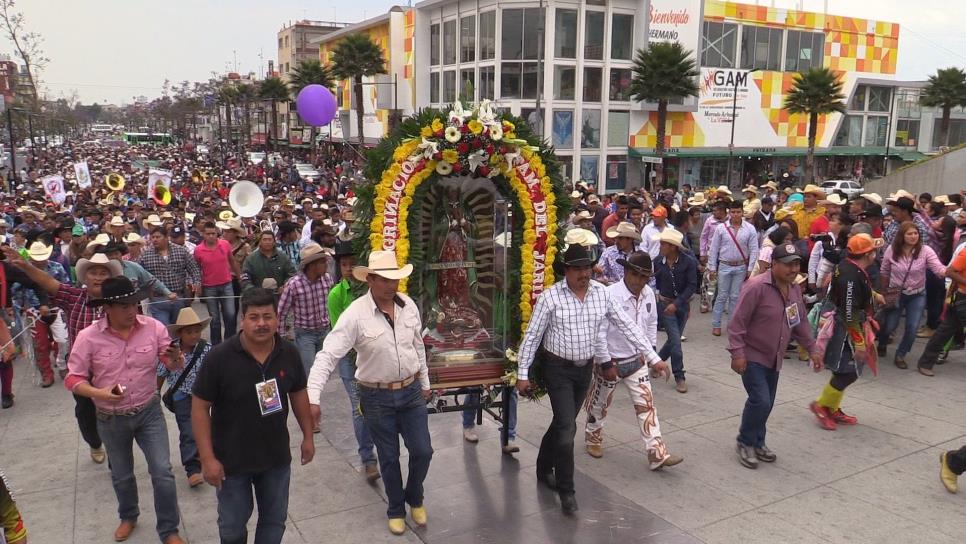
[576,440,752,530]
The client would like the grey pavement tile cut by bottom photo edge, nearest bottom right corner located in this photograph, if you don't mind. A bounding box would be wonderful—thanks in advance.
[759,486,962,544]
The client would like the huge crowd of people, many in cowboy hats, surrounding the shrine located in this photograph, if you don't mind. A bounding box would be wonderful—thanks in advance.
[0,135,966,544]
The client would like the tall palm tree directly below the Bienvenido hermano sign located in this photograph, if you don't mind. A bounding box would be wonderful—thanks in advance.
[630,42,700,185]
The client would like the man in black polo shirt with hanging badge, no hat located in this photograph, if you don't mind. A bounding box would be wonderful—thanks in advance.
[191,288,315,544]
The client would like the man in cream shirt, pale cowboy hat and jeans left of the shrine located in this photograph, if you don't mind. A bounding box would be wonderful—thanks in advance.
[308,251,433,535]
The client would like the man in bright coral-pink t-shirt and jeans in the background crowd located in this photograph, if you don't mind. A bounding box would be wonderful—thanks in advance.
[195,221,241,346]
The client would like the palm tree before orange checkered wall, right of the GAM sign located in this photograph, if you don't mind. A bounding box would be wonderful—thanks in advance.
[785,67,845,183]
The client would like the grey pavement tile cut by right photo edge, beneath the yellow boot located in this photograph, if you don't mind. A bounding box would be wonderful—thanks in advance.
[829,448,966,539]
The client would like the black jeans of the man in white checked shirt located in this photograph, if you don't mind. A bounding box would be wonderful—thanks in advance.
[537,358,593,495]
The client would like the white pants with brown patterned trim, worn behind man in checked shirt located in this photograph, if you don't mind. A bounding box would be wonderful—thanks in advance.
[584,365,670,470]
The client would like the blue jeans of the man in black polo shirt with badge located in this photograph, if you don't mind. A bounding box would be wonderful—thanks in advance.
[215,464,292,544]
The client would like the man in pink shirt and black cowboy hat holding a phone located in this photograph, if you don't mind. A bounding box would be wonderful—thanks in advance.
[64,276,184,544]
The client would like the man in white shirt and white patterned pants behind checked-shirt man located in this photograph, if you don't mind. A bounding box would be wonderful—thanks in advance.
[584,251,683,470]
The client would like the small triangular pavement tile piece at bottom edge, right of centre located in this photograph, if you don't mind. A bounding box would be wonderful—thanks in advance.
[693,510,831,544]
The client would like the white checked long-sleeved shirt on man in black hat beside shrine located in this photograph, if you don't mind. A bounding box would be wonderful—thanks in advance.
[518,280,660,380]
